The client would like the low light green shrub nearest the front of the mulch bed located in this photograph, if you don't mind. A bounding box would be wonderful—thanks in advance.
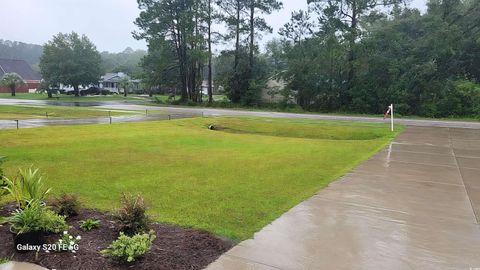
[100,231,156,263]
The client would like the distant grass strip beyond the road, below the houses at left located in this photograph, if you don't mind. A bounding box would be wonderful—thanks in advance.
[0,93,148,102]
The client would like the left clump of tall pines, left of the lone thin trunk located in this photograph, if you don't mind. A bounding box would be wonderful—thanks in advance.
[134,0,208,101]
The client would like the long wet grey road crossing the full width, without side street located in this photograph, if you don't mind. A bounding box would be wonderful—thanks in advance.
[0,99,480,129]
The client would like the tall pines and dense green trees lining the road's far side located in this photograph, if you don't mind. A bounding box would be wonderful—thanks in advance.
[139,0,480,117]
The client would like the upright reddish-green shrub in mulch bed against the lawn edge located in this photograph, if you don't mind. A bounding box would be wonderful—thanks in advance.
[113,193,150,235]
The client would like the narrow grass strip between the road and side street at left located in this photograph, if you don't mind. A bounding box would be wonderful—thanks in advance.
[0,105,134,119]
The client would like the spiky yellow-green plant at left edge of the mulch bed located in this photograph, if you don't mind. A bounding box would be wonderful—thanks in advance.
[3,167,51,209]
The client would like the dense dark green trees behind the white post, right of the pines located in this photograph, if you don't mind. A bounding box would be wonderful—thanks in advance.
[277,0,480,117]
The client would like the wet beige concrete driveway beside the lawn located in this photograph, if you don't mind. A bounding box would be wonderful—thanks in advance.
[207,127,480,270]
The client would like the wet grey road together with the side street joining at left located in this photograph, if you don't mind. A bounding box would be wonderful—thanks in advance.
[0,99,480,129]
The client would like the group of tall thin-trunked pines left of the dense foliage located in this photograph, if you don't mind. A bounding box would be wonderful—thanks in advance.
[134,0,282,104]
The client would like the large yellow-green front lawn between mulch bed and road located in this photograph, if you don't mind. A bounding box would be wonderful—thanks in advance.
[0,118,398,240]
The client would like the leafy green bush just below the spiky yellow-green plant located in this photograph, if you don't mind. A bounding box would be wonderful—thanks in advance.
[7,201,68,233]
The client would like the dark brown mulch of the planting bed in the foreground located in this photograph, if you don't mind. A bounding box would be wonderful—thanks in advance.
[0,205,233,270]
